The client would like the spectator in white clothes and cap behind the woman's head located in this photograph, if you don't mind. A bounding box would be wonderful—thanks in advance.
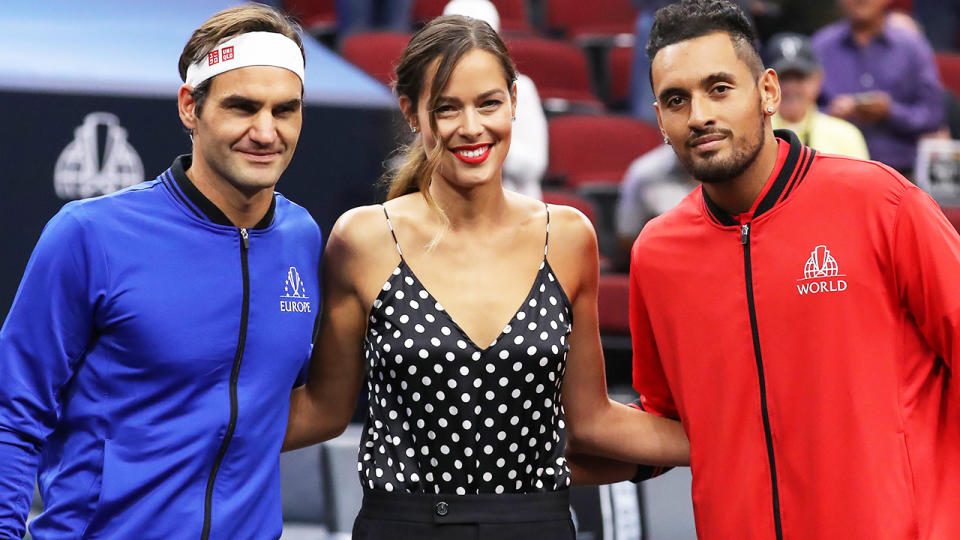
[443,0,549,199]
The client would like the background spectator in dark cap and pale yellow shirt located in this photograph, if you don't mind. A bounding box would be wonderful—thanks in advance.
[763,33,870,159]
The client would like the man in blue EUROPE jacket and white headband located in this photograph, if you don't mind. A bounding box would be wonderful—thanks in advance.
[0,5,321,540]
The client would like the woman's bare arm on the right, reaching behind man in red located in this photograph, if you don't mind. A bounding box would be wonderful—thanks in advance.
[550,207,690,468]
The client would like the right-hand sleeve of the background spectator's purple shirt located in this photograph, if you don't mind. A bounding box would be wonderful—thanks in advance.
[886,39,944,136]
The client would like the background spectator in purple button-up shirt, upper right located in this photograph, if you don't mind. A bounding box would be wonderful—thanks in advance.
[813,0,943,175]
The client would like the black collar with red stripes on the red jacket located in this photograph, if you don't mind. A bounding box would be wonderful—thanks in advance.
[700,129,816,226]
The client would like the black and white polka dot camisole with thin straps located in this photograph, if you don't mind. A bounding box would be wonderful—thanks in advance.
[357,207,572,495]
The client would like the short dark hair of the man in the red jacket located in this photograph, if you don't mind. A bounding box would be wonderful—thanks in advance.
[646,0,763,79]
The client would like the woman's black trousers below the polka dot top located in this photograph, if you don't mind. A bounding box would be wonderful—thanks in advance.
[353,490,576,540]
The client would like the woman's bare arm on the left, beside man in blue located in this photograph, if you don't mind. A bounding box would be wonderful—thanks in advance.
[283,207,389,451]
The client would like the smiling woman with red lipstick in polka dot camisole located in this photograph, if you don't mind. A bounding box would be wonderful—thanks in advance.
[284,16,689,539]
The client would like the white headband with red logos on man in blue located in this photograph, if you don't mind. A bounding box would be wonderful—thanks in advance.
[186,32,303,88]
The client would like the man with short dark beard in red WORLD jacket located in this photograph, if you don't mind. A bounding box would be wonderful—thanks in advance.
[630,0,960,540]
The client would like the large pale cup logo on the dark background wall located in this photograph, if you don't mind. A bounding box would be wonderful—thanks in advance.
[53,112,143,200]
